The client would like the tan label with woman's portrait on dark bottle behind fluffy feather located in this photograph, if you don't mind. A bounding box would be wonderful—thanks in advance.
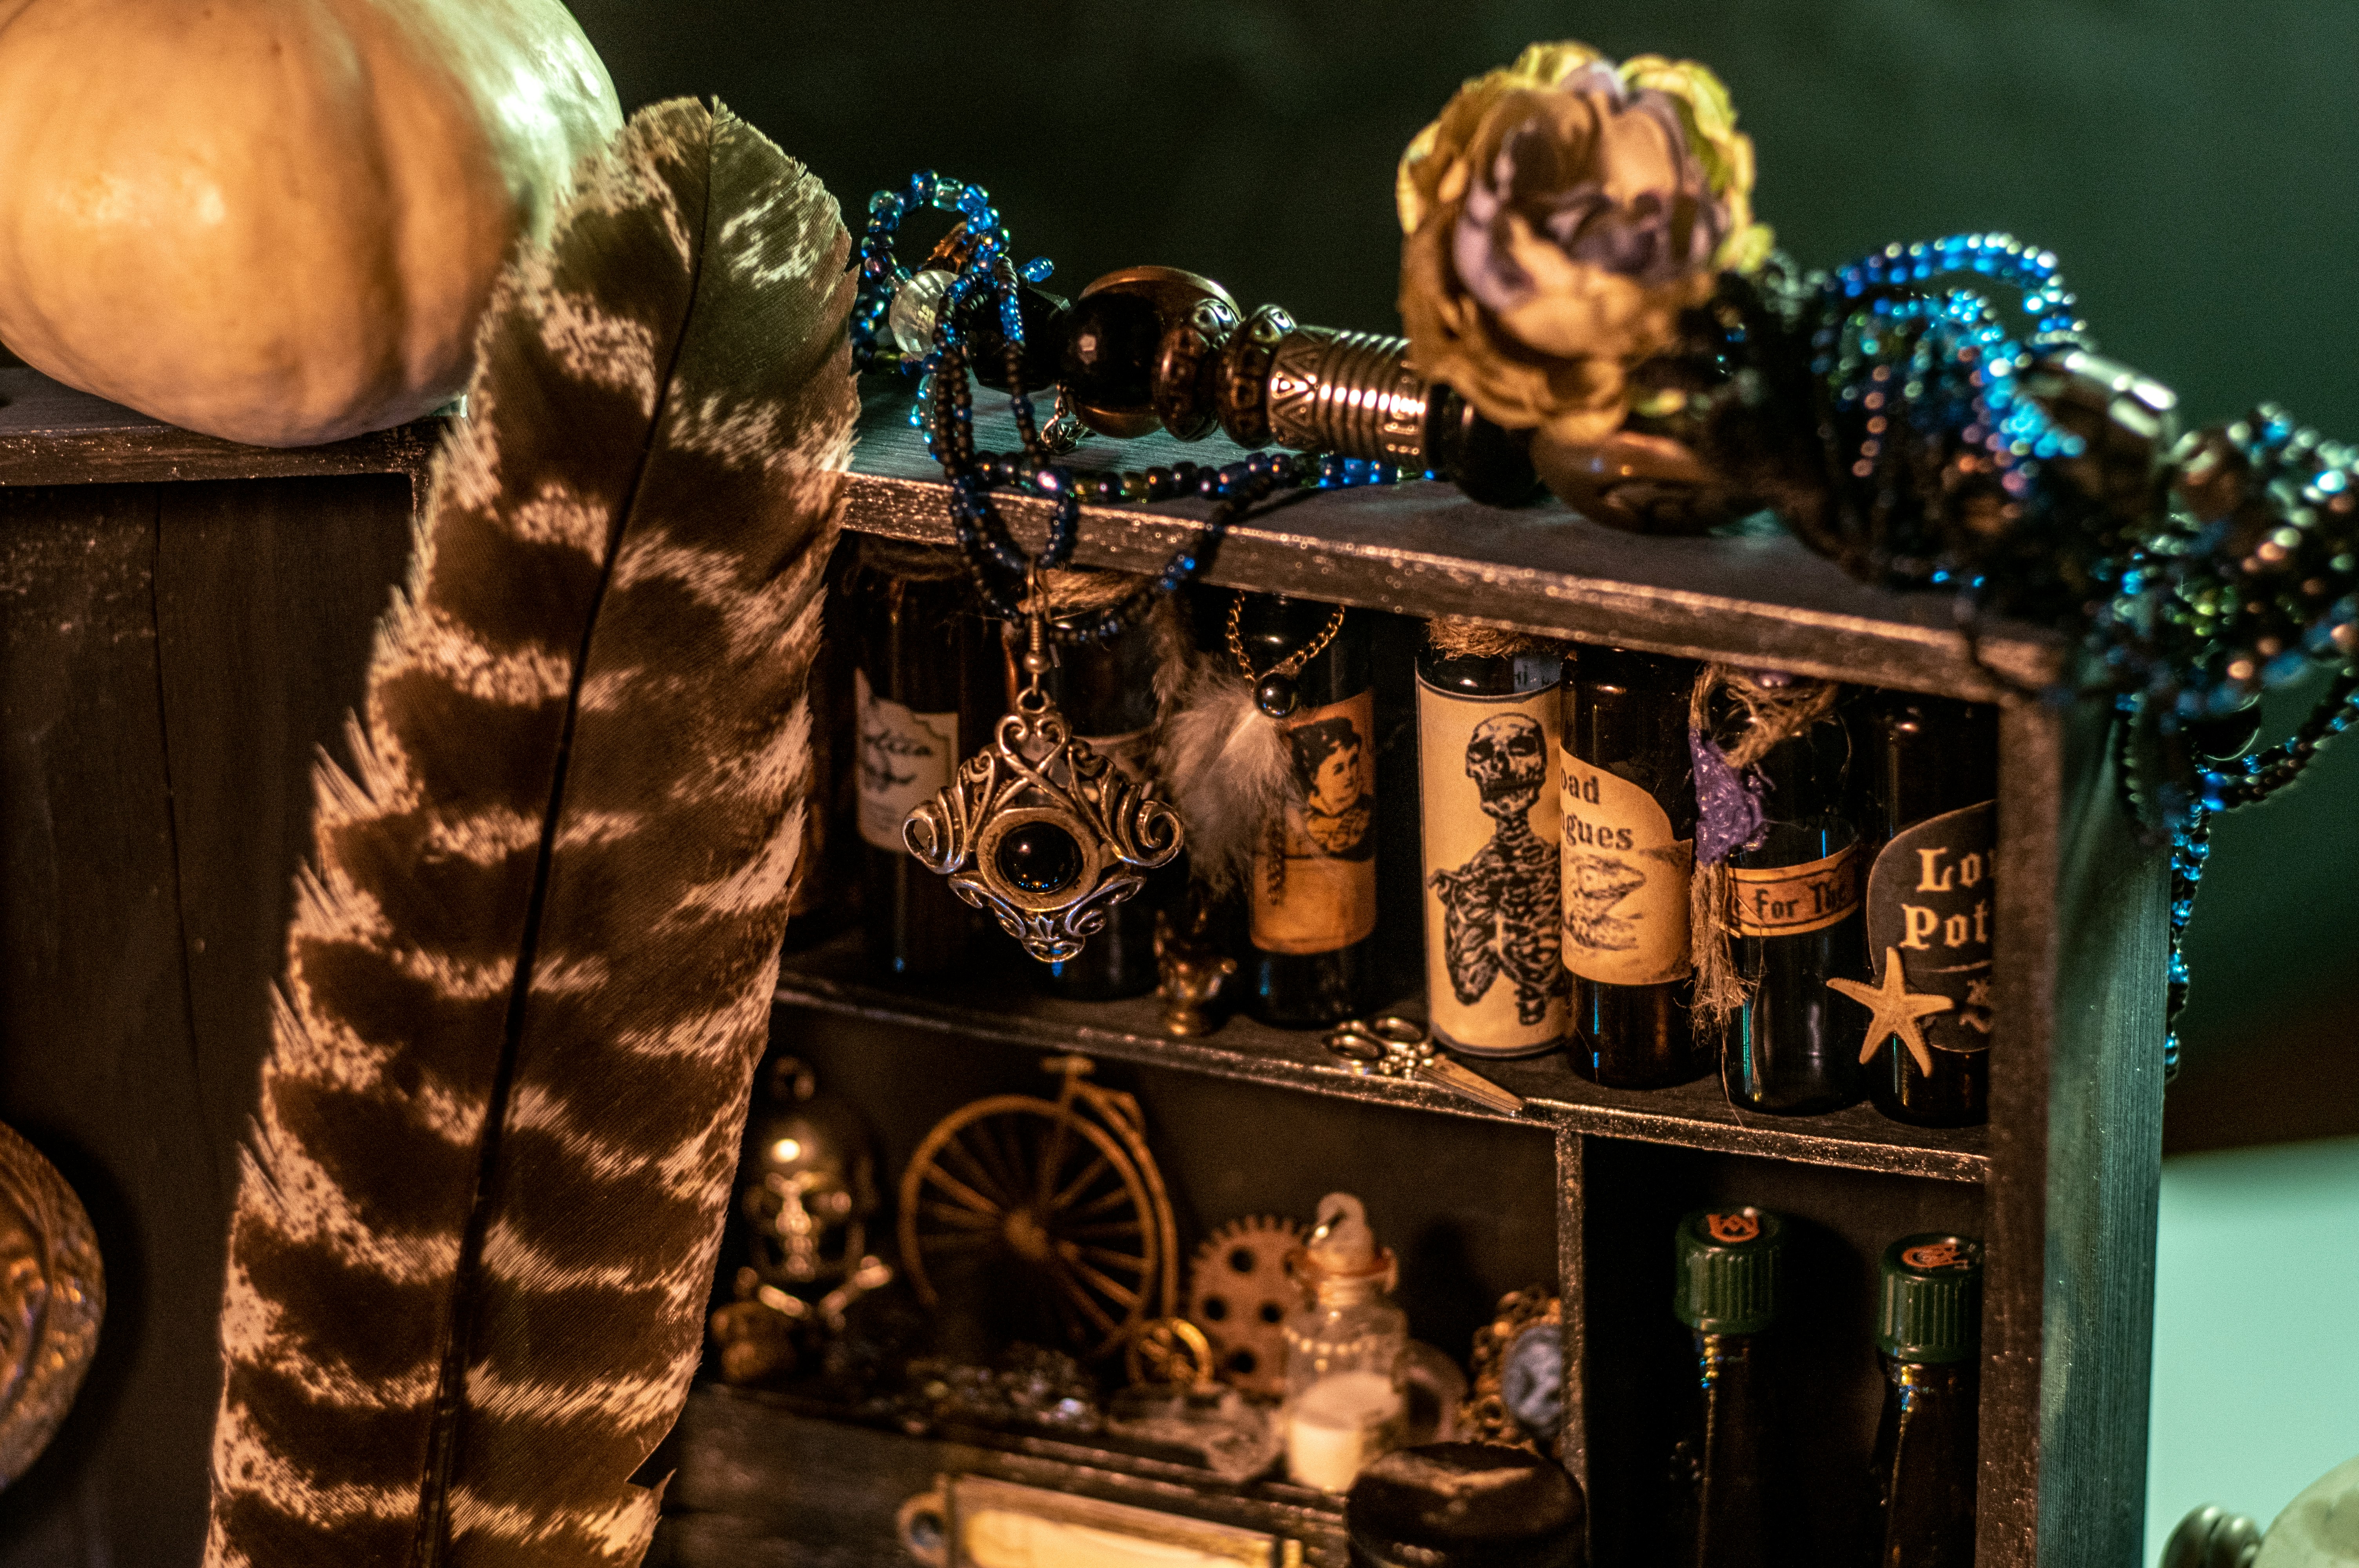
[1252,691,1375,953]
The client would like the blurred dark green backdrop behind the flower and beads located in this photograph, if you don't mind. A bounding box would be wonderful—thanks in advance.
[571,0,2359,1148]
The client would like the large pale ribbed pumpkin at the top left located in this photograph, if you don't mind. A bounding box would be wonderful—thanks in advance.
[0,0,623,446]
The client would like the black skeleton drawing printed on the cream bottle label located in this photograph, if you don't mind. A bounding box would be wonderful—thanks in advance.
[1430,712,1559,1024]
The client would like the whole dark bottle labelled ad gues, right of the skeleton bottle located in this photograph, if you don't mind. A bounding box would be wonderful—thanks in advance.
[1562,648,1713,1089]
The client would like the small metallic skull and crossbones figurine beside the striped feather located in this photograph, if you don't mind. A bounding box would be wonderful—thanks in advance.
[710,1056,892,1382]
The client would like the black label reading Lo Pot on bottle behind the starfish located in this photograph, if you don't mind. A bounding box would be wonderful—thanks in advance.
[1868,802,1998,1054]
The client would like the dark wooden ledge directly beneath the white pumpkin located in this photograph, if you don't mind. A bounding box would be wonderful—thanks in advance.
[0,365,451,486]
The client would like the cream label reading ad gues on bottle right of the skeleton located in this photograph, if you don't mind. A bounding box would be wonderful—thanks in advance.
[1559,752,1696,985]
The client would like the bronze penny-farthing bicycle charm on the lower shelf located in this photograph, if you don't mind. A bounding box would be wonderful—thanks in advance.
[901,1056,1177,1356]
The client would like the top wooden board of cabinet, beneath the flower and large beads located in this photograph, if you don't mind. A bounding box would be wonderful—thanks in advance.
[845,382,2069,700]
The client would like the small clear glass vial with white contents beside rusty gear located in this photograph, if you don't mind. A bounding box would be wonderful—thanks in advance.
[1279,1193,1408,1493]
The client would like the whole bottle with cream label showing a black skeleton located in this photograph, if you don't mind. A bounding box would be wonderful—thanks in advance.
[1418,641,1564,1056]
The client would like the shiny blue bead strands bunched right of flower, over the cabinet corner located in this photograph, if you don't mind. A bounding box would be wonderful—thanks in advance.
[1713,233,2359,1075]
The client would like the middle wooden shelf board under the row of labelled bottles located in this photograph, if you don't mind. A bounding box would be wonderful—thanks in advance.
[778,936,1988,1181]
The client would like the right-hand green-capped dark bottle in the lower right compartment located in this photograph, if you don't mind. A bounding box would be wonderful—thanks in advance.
[1873,1236,1981,1568]
